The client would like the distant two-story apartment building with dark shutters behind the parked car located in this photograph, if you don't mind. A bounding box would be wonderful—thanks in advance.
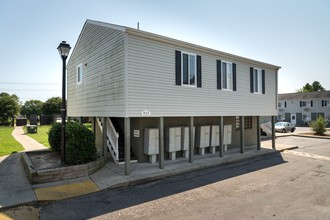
[277,91,330,126]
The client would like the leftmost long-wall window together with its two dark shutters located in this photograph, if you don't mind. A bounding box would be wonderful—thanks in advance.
[175,51,202,87]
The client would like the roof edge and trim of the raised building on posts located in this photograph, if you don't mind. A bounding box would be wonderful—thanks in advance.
[68,19,281,70]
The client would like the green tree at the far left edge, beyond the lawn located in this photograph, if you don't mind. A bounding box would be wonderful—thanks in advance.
[0,92,20,125]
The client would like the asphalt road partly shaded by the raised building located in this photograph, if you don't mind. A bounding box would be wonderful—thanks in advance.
[40,137,330,219]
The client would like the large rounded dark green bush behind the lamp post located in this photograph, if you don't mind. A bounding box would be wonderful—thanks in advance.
[48,122,96,165]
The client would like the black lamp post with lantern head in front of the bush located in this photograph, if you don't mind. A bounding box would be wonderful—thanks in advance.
[57,41,71,163]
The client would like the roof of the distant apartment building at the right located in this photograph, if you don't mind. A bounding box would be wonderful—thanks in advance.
[278,90,330,101]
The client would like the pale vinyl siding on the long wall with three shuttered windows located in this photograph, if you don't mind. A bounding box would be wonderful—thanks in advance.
[127,35,277,117]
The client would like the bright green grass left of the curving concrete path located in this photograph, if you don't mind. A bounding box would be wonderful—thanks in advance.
[0,126,24,156]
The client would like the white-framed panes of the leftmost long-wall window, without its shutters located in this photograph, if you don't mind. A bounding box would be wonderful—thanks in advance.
[181,52,197,86]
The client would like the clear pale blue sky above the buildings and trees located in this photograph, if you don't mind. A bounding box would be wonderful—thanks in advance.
[0,0,330,103]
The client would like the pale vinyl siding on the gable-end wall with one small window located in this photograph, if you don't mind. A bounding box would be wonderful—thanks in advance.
[67,23,125,117]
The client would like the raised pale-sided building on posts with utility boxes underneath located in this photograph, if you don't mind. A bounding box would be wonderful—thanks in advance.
[67,20,280,173]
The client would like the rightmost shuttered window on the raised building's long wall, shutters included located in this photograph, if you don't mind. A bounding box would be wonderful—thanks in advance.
[250,67,265,94]
